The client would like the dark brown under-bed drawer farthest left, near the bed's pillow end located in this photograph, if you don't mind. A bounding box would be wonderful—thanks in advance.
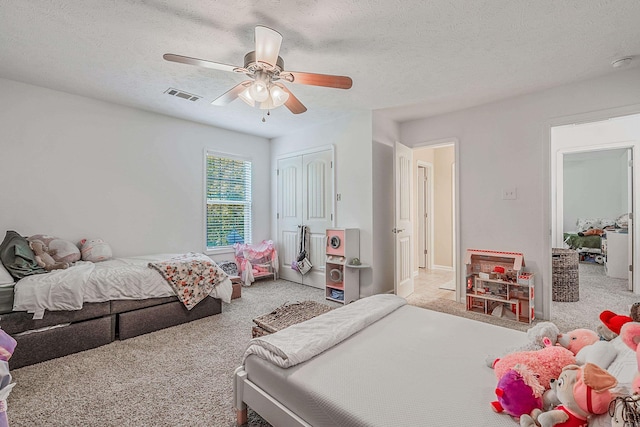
[9,316,115,369]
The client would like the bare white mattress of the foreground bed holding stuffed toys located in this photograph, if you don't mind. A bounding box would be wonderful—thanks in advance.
[245,305,527,427]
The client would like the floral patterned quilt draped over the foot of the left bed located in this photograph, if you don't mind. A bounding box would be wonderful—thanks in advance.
[149,253,227,310]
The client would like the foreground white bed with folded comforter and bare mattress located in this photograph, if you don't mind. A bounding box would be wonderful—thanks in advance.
[234,295,637,427]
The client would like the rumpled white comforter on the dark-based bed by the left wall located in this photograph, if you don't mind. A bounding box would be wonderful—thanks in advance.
[13,254,232,319]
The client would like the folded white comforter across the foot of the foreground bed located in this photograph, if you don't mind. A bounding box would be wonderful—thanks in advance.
[242,294,407,368]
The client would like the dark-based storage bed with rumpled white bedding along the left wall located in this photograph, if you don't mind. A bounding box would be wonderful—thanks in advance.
[0,254,232,369]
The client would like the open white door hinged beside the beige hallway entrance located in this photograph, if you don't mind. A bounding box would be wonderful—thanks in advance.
[393,142,414,297]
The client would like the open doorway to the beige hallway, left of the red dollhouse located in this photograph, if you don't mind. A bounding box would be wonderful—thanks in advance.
[413,143,457,300]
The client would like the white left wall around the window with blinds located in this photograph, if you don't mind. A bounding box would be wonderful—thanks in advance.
[0,79,271,259]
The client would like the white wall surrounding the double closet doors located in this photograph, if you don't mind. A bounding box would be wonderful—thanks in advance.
[271,112,379,296]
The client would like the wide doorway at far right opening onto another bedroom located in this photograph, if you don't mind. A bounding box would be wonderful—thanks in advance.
[547,115,640,320]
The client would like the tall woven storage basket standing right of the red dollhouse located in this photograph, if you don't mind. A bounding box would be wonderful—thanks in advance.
[551,248,580,302]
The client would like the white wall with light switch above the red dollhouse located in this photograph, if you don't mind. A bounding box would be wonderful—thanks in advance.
[400,68,640,316]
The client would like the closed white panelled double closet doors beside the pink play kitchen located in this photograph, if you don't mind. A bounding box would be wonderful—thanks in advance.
[278,150,334,289]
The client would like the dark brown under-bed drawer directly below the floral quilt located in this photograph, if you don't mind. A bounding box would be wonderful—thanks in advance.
[117,297,222,340]
